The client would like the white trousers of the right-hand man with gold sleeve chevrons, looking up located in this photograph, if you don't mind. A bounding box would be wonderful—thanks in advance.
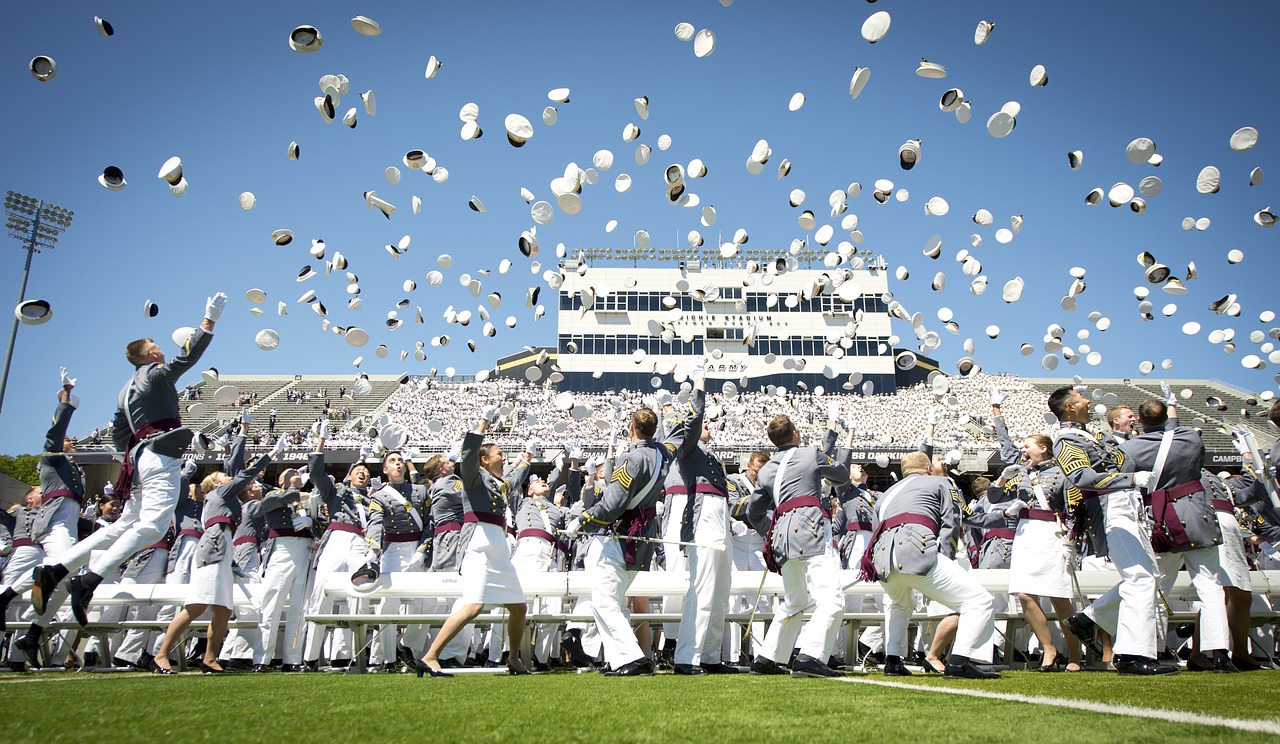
[1084,490,1162,658]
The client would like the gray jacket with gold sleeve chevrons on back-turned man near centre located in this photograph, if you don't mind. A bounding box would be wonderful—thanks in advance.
[582,434,680,571]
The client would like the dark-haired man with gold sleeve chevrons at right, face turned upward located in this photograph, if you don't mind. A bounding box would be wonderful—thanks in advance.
[1048,387,1178,675]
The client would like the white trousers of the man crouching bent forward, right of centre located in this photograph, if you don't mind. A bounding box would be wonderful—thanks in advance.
[881,556,996,663]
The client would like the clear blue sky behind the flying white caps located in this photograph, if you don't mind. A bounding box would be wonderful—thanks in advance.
[0,0,1280,452]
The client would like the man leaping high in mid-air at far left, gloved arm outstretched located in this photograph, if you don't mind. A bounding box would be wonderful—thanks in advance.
[31,292,227,625]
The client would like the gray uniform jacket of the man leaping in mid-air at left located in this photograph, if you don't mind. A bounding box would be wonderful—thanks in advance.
[111,328,214,457]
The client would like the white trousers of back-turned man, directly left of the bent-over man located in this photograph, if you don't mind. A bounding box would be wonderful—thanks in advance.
[760,544,845,663]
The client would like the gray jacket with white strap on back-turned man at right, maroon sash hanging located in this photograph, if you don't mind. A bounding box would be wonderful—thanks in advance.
[1120,426,1222,552]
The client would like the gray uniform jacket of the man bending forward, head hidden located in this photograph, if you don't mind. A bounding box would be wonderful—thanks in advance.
[868,474,969,580]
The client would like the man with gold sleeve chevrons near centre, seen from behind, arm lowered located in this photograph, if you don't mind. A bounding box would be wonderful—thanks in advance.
[564,408,682,676]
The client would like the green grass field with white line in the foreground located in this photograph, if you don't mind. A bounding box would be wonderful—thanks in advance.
[0,672,1280,744]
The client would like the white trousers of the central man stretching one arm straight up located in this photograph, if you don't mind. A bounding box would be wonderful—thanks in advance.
[676,494,733,666]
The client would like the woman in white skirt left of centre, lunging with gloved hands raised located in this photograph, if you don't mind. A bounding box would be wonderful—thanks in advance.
[416,406,536,677]
